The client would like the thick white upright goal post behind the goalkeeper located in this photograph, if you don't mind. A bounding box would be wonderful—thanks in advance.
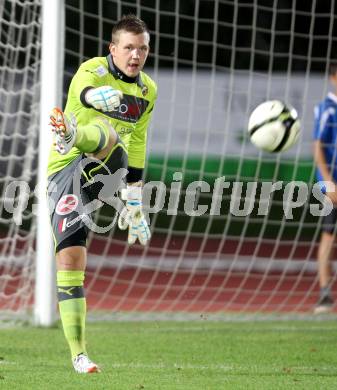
[34,0,64,326]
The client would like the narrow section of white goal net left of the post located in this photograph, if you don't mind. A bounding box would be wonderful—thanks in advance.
[0,1,41,320]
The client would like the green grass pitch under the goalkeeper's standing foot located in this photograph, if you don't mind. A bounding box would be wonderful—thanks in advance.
[0,320,337,390]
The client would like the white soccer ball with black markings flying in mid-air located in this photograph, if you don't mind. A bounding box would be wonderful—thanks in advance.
[248,100,301,153]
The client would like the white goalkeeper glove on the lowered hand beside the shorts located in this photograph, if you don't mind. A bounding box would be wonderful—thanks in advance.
[118,185,151,245]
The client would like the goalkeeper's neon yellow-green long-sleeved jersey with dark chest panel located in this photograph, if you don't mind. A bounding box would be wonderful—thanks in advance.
[48,55,157,176]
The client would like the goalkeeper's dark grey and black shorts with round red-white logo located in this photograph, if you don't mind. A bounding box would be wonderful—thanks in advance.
[47,142,128,252]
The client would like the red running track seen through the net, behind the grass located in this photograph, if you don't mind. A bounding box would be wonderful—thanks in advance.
[0,238,328,313]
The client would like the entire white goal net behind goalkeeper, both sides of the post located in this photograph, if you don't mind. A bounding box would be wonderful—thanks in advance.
[0,0,336,319]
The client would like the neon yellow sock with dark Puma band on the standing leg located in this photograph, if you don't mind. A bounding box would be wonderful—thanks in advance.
[57,271,86,358]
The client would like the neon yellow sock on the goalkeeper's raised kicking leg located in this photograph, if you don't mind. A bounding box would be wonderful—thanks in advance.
[75,118,110,153]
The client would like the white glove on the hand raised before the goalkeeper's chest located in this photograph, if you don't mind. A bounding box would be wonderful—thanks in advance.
[85,85,123,112]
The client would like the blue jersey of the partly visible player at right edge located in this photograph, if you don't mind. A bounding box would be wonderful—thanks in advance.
[314,92,337,181]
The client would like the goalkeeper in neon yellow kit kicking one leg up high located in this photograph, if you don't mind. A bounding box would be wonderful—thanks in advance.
[48,15,157,373]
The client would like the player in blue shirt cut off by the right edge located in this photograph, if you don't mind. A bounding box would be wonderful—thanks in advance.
[314,63,337,313]
